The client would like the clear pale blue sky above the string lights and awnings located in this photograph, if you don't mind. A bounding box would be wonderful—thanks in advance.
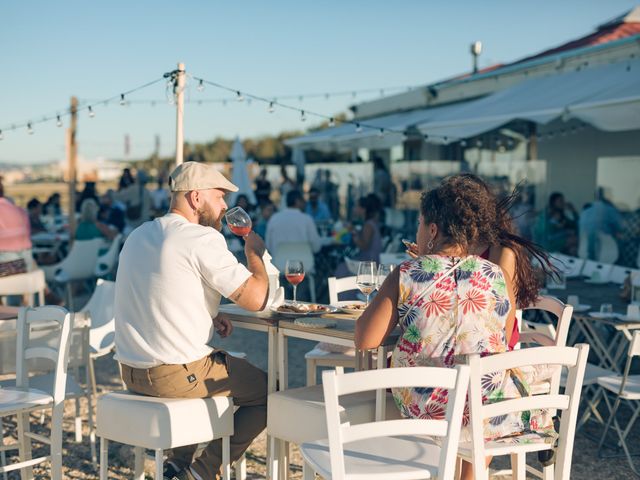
[0,0,639,164]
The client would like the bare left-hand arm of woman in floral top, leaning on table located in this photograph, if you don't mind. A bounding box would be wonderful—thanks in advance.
[355,268,399,350]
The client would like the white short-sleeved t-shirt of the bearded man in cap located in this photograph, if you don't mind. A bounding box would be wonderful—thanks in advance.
[115,213,251,368]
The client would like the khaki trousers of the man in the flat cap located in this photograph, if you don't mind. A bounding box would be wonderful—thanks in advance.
[122,350,267,480]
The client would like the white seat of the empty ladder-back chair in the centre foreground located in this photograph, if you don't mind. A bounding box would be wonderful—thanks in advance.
[302,436,440,480]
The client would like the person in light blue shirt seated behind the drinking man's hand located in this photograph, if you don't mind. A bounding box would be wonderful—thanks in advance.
[266,190,322,255]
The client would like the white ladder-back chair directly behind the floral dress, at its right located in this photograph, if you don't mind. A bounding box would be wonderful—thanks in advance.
[458,344,589,480]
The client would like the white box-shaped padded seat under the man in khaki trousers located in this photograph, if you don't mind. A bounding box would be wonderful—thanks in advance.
[96,391,233,449]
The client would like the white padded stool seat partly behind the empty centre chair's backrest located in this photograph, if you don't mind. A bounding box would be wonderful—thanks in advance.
[267,385,401,445]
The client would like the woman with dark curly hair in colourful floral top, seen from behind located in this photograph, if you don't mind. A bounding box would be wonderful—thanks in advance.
[356,174,553,479]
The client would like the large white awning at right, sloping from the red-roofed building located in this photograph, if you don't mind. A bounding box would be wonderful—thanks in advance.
[418,59,640,139]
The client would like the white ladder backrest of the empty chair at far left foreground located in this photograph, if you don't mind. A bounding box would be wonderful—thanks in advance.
[16,305,73,404]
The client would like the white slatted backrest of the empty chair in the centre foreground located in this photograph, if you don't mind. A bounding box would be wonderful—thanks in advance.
[322,365,469,480]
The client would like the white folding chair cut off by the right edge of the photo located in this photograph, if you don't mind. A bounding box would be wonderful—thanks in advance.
[598,330,640,476]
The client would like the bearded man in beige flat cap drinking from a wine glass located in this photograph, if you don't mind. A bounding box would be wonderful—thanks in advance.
[115,162,268,480]
